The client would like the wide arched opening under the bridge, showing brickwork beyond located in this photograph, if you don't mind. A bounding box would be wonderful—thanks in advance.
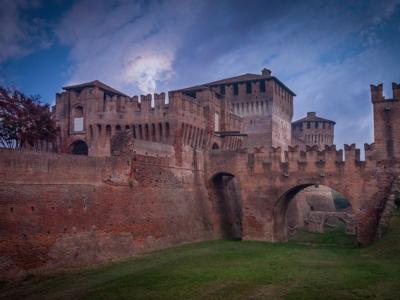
[274,184,356,243]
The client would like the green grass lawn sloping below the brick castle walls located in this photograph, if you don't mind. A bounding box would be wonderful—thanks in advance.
[0,211,400,300]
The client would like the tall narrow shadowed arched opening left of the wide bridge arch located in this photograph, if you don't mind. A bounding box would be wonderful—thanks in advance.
[211,173,242,239]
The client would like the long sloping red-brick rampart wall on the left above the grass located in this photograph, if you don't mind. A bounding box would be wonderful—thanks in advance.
[0,150,217,278]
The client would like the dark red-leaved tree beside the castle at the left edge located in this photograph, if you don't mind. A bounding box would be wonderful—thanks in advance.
[0,86,57,149]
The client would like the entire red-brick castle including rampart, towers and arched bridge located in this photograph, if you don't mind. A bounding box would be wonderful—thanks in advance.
[0,70,400,277]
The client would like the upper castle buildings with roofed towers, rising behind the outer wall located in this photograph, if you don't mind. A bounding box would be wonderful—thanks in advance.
[55,69,335,156]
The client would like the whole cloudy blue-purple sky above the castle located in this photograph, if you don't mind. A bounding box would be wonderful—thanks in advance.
[0,0,400,148]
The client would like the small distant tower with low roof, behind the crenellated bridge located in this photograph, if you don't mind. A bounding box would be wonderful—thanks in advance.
[292,112,336,149]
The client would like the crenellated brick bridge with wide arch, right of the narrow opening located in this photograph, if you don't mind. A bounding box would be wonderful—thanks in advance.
[206,144,391,244]
